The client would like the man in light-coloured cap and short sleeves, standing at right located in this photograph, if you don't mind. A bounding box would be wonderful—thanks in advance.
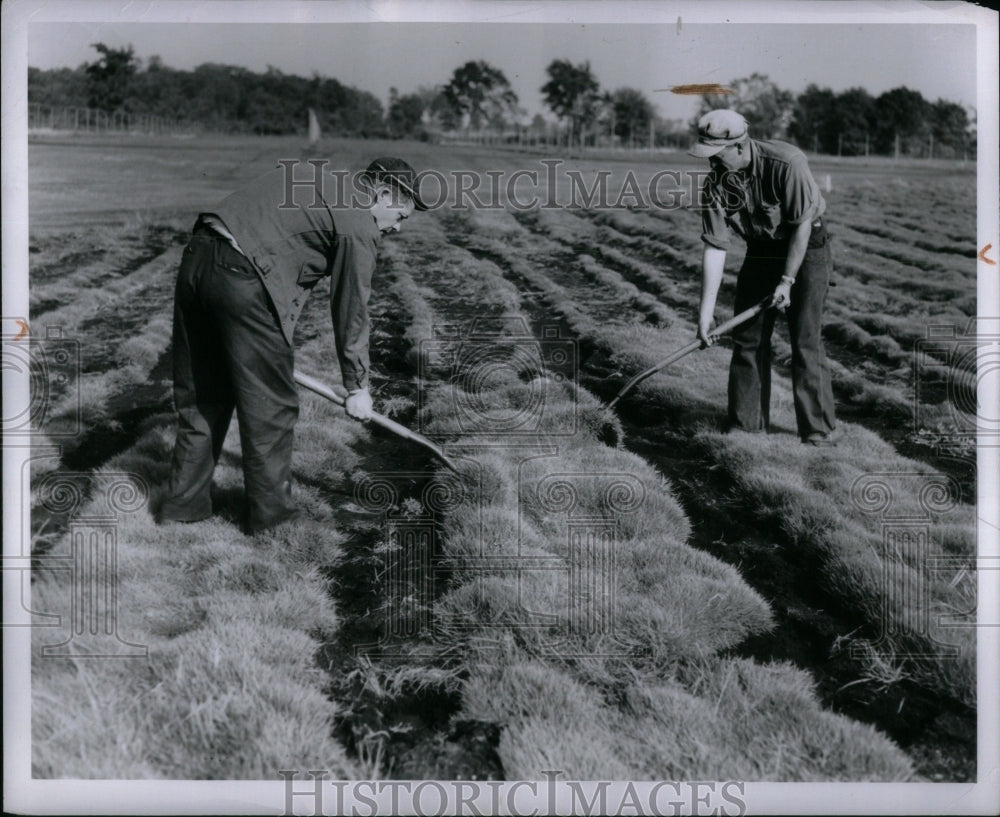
[689,109,836,446]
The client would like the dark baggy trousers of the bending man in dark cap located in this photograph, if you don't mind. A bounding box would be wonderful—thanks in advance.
[161,226,299,530]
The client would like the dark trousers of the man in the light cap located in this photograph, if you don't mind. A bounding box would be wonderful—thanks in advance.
[729,218,836,440]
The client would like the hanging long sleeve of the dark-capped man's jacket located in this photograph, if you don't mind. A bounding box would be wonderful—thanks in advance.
[330,235,375,389]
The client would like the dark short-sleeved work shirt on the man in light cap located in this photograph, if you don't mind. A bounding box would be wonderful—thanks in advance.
[701,139,826,250]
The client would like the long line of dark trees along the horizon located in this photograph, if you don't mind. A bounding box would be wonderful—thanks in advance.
[28,43,975,158]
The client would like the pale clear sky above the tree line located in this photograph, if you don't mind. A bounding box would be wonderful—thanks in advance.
[28,11,976,118]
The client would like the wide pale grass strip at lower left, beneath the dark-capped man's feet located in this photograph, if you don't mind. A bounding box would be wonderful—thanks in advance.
[32,452,357,780]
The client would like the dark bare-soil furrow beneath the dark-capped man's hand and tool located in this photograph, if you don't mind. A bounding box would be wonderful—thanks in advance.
[295,245,503,779]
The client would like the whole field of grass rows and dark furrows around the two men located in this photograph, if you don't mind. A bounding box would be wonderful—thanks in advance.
[23,137,976,781]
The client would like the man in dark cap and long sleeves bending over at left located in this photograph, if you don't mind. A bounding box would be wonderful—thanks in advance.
[160,158,427,532]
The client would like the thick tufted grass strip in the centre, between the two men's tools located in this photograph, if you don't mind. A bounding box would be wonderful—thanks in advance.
[376,209,911,780]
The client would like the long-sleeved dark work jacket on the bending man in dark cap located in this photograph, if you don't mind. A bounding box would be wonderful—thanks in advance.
[209,167,381,389]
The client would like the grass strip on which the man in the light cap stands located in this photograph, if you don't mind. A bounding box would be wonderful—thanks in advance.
[442,209,975,720]
